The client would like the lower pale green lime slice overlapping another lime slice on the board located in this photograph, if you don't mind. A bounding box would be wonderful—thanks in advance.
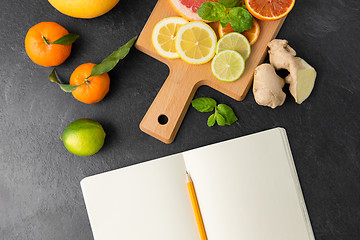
[211,50,245,82]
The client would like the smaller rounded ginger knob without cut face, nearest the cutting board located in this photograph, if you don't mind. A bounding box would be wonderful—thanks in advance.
[253,63,286,108]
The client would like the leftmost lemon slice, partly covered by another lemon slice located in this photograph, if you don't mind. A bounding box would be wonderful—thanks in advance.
[151,17,188,58]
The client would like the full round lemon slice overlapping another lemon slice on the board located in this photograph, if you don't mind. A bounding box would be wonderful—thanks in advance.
[175,21,217,64]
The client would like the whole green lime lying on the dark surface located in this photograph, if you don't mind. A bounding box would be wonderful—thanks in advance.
[60,119,106,156]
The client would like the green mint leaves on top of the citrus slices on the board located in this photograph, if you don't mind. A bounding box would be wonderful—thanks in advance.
[196,0,253,33]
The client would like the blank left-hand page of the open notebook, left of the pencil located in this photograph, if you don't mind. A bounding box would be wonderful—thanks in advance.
[81,154,199,240]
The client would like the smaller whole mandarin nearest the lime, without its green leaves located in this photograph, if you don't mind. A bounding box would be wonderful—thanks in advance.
[70,63,110,104]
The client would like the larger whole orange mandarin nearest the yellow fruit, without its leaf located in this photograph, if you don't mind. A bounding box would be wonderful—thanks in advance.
[25,22,72,67]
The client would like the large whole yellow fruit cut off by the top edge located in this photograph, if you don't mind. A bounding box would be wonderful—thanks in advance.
[49,0,119,18]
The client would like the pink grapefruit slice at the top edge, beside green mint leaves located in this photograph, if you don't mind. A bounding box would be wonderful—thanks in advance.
[169,0,217,21]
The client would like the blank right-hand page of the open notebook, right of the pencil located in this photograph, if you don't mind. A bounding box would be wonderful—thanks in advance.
[183,128,314,240]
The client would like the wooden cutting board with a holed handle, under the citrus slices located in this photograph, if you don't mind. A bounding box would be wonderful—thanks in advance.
[135,0,285,143]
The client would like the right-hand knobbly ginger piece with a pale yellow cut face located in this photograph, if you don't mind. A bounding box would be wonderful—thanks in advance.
[268,39,316,104]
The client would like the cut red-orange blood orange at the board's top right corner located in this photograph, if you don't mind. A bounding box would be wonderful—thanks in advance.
[245,0,295,21]
